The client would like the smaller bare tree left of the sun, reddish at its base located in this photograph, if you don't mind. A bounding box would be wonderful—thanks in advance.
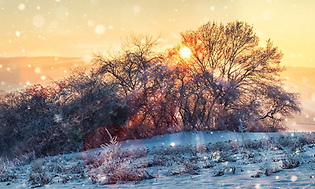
[93,35,177,138]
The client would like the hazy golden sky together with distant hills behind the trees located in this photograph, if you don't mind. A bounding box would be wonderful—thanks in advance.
[0,0,315,131]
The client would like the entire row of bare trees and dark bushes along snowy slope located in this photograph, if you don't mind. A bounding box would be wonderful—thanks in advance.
[0,21,300,156]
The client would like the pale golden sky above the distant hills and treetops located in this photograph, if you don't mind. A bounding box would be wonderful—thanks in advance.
[0,0,315,67]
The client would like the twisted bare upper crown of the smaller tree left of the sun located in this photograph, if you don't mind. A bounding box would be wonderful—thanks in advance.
[93,35,163,96]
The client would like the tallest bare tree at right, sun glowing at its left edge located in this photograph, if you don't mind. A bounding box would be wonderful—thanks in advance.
[169,21,300,131]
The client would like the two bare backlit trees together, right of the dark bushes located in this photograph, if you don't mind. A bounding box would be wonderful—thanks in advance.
[94,21,300,133]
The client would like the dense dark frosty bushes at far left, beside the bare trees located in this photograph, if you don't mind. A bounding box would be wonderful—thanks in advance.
[0,68,128,157]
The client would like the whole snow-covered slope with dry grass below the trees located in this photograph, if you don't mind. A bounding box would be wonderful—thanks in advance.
[0,132,315,188]
